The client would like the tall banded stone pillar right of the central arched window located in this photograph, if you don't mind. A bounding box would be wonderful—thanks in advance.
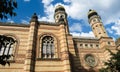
[60,24,71,72]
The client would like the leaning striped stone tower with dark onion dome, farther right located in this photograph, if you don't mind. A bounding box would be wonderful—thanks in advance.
[88,9,108,38]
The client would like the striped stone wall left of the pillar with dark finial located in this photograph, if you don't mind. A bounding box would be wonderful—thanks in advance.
[0,24,29,72]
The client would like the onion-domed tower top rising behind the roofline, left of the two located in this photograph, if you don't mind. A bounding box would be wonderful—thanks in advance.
[54,5,69,34]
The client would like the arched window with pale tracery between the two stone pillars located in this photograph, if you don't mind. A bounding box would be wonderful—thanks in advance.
[41,36,54,58]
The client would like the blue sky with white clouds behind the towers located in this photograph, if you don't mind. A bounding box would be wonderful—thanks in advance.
[2,0,120,40]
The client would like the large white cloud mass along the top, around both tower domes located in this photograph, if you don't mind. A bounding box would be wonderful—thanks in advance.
[42,0,120,24]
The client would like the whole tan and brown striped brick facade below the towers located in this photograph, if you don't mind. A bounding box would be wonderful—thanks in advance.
[0,7,116,72]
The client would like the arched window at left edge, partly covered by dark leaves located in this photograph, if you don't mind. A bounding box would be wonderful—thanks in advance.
[0,36,16,60]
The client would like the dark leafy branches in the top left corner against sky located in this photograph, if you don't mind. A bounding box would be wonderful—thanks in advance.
[0,0,17,19]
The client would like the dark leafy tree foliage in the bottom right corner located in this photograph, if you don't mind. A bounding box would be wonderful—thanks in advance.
[99,49,120,72]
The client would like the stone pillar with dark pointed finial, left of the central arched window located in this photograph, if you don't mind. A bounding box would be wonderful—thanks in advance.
[24,14,38,72]
